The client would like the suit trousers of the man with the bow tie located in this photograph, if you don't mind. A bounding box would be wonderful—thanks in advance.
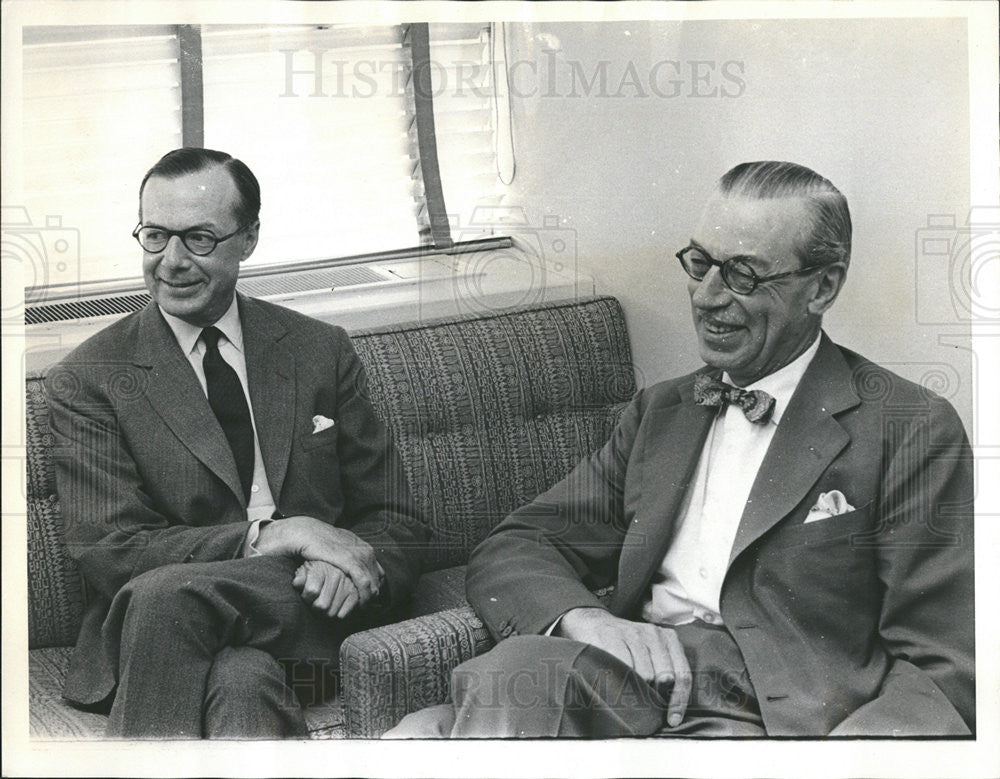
[385,622,765,738]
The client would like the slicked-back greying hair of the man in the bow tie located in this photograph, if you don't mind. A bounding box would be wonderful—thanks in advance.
[718,160,851,268]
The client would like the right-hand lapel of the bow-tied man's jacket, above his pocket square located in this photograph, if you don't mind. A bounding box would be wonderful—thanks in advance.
[729,334,859,566]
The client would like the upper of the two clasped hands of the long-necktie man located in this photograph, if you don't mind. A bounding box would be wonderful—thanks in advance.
[256,515,382,605]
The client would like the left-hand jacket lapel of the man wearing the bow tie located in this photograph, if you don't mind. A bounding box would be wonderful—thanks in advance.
[615,375,717,608]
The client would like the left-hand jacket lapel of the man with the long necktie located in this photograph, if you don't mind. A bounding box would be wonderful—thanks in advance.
[135,303,245,505]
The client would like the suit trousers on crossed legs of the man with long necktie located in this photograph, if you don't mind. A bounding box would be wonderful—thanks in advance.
[102,556,342,738]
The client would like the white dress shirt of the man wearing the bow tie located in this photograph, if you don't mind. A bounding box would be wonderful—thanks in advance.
[642,335,819,625]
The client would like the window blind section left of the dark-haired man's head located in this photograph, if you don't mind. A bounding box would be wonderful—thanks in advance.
[19,26,181,286]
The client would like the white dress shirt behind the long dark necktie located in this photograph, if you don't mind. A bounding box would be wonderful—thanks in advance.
[160,296,275,532]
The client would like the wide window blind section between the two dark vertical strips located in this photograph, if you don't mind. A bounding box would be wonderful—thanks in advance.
[202,26,418,264]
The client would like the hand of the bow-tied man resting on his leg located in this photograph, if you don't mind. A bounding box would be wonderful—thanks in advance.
[553,608,692,727]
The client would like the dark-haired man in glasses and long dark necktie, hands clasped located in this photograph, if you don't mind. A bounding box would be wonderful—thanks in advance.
[47,148,425,738]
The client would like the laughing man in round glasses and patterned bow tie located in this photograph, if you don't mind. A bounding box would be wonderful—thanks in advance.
[387,162,975,737]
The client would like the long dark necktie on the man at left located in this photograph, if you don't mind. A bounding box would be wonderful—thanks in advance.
[201,327,254,502]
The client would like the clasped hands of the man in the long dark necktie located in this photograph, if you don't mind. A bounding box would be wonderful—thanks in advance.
[256,515,385,619]
